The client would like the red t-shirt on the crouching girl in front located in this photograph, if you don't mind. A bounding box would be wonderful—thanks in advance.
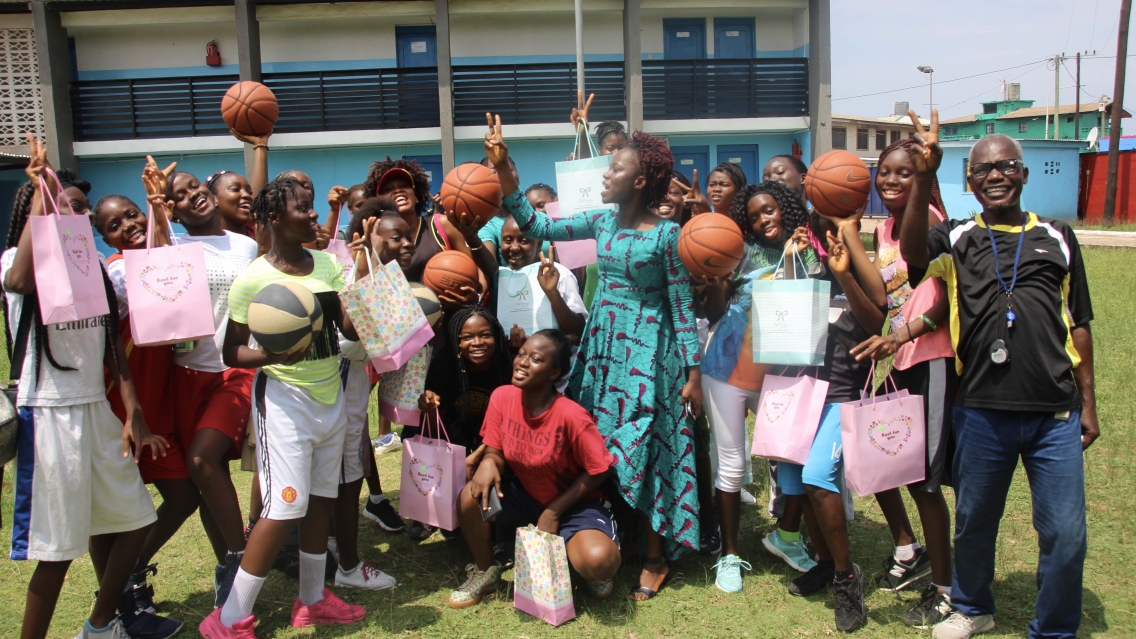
[482,384,612,506]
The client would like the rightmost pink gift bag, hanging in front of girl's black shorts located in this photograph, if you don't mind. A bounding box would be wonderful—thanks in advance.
[841,375,927,497]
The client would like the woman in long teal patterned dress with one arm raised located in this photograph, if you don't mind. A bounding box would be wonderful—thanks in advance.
[485,111,702,600]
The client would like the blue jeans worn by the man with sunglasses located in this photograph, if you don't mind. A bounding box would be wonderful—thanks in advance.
[951,406,1086,639]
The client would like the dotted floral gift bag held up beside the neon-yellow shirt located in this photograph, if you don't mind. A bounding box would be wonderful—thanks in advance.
[340,247,434,373]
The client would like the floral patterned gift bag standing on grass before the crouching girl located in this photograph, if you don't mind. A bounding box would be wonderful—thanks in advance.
[512,525,576,625]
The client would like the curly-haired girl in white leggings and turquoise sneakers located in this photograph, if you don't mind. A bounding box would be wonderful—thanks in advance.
[702,176,818,592]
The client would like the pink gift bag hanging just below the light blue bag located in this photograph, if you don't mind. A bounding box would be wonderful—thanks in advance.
[751,375,828,459]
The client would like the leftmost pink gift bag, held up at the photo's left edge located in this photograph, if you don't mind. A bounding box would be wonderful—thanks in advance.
[28,168,110,324]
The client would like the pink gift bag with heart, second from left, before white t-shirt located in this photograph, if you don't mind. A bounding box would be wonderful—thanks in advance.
[123,207,218,346]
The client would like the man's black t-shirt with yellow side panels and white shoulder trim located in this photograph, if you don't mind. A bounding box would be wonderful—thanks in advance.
[927,213,1093,412]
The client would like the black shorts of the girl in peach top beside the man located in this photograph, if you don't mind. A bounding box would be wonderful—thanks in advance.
[892,358,959,492]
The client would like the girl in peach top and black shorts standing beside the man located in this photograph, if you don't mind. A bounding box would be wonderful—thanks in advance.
[854,135,958,628]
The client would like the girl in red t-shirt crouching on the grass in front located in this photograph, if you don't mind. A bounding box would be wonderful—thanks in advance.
[450,330,619,608]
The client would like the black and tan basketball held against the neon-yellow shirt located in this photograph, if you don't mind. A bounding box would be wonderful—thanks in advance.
[249,281,324,354]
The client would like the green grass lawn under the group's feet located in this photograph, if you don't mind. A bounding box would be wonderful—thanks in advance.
[0,248,1136,639]
